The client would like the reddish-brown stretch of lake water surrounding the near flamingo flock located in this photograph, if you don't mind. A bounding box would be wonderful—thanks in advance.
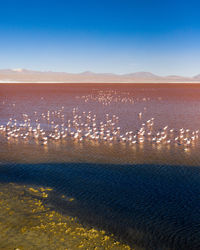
[0,84,200,166]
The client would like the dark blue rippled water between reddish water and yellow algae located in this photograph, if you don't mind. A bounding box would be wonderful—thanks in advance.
[0,163,200,250]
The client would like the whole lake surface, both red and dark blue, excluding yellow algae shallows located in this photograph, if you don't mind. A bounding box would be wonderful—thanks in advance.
[0,84,200,249]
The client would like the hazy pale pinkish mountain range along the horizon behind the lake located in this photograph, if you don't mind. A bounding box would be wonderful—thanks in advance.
[0,69,200,83]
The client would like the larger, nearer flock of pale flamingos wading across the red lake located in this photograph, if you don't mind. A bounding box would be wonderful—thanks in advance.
[0,101,199,151]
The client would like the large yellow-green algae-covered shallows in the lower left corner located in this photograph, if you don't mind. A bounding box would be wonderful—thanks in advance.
[0,184,134,250]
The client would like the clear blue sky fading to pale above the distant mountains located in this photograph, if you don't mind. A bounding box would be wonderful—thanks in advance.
[0,0,200,76]
